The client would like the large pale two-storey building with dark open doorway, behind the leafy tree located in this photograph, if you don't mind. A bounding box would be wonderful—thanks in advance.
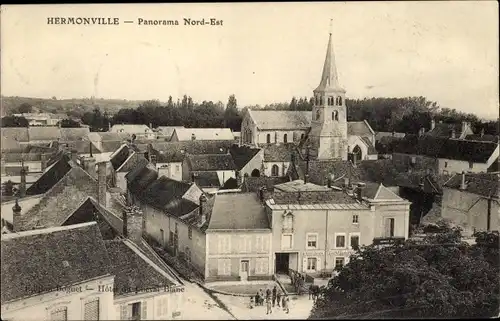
[260,180,410,276]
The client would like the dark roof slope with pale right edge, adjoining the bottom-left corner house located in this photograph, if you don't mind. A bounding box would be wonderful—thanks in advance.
[104,239,174,295]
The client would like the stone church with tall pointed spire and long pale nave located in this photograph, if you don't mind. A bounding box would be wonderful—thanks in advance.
[240,28,377,161]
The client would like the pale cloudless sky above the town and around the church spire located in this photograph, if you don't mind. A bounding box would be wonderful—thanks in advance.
[0,1,499,118]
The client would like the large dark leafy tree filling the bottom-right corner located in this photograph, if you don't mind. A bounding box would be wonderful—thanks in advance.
[310,222,500,319]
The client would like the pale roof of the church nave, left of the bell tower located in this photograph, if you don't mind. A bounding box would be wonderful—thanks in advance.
[248,109,312,130]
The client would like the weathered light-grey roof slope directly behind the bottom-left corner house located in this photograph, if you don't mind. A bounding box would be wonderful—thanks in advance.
[20,167,98,230]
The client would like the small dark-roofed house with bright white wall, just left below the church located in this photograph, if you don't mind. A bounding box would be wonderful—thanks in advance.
[182,154,236,187]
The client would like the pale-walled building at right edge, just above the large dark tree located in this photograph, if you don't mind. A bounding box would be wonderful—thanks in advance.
[441,173,500,236]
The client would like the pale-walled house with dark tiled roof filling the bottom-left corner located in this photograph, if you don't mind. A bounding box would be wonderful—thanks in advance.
[1,222,115,320]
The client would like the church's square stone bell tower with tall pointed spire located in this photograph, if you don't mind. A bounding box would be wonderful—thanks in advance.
[309,20,347,160]
